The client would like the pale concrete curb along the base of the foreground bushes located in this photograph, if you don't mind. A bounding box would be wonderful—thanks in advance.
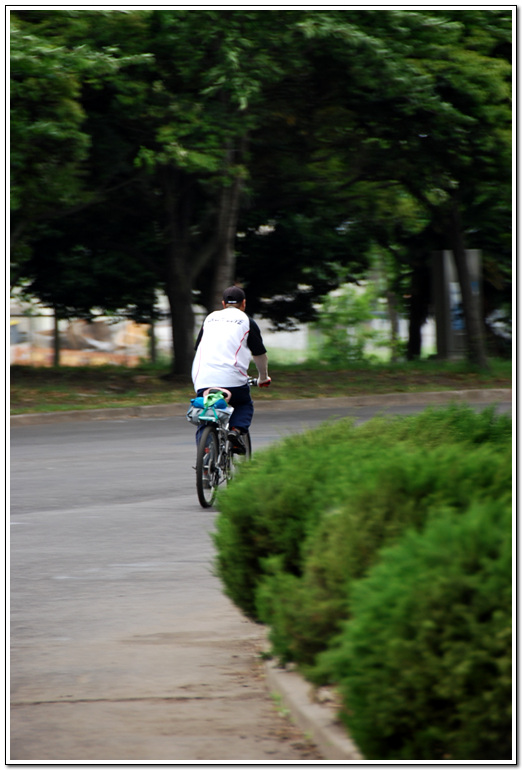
[265,661,364,762]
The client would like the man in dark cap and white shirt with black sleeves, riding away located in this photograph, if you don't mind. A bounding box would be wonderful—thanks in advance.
[192,286,271,454]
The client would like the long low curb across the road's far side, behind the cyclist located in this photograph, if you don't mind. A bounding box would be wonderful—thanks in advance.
[11,388,512,427]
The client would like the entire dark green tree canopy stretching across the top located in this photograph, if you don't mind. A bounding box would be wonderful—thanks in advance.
[11,9,511,363]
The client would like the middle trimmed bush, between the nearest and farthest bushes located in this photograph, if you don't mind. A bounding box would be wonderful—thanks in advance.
[256,444,511,668]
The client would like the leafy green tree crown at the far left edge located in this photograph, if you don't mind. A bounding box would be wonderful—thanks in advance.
[10,12,156,310]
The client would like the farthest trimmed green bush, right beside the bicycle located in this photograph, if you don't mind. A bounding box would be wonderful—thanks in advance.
[214,406,511,621]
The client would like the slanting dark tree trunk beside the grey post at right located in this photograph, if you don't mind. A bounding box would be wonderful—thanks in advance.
[449,199,489,370]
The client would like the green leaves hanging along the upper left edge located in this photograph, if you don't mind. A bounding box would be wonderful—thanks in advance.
[10,11,152,284]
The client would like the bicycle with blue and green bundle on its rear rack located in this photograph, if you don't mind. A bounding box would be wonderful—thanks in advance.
[187,377,266,508]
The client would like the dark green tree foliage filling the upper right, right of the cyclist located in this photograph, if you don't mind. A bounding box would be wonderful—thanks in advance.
[238,9,512,340]
